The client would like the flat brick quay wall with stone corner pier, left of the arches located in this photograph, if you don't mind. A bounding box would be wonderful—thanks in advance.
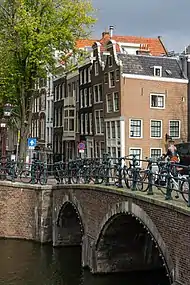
[0,182,52,243]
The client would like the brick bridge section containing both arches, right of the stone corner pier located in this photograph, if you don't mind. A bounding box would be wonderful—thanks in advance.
[52,185,190,285]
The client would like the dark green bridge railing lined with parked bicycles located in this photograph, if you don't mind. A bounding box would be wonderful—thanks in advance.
[0,154,190,206]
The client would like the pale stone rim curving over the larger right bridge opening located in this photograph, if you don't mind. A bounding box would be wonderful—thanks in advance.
[94,201,175,284]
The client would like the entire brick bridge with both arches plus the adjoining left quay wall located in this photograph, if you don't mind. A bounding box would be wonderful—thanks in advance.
[0,181,190,285]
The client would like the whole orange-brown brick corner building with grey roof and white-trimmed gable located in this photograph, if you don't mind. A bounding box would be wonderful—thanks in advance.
[103,40,188,158]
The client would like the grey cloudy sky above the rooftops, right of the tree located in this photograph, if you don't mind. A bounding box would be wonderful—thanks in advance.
[92,0,190,52]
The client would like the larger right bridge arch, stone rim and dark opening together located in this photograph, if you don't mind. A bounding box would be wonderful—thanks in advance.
[94,201,174,284]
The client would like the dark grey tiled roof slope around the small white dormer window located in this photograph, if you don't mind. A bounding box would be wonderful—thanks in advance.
[117,54,186,79]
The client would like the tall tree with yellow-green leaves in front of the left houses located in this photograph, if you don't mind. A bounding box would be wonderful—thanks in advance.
[0,0,95,155]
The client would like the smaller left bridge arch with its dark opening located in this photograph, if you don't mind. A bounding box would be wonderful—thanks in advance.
[56,200,85,246]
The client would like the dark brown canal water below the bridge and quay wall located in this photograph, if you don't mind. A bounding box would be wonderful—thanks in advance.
[0,239,170,285]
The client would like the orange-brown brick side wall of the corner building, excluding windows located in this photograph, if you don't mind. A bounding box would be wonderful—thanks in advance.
[121,78,188,158]
